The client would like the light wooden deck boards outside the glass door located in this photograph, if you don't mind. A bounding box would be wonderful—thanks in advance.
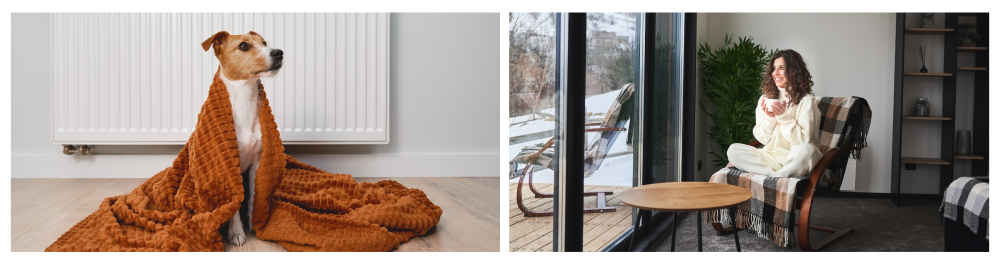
[508,183,632,252]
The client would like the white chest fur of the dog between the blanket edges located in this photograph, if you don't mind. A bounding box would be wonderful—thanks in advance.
[221,75,263,172]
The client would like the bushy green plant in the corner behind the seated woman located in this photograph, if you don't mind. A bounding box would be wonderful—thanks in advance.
[698,34,778,166]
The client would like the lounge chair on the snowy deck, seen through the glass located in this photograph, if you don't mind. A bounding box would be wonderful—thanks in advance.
[510,84,634,217]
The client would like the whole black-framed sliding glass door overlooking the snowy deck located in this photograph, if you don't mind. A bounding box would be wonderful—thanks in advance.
[509,13,684,251]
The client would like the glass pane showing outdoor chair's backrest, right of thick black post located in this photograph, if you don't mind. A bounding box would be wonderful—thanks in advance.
[582,13,641,251]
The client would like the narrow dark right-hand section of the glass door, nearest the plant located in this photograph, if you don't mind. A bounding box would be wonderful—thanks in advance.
[624,13,696,251]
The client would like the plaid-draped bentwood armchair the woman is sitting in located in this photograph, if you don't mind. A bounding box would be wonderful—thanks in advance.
[709,97,871,251]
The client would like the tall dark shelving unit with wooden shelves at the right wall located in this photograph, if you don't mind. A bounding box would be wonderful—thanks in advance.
[889,11,990,207]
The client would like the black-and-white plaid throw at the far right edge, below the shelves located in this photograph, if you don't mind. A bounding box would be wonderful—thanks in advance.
[940,177,990,240]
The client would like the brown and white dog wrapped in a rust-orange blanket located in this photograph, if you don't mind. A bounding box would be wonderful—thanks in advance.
[201,31,284,246]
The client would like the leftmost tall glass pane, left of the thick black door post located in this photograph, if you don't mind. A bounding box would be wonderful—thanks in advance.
[508,13,558,252]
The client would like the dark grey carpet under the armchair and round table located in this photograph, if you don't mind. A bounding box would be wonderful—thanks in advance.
[651,198,944,252]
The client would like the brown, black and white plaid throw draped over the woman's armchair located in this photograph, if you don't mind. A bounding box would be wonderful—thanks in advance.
[705,97,871,247]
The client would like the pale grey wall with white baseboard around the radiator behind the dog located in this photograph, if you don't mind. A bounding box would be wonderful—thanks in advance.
[11,14,507,178]
